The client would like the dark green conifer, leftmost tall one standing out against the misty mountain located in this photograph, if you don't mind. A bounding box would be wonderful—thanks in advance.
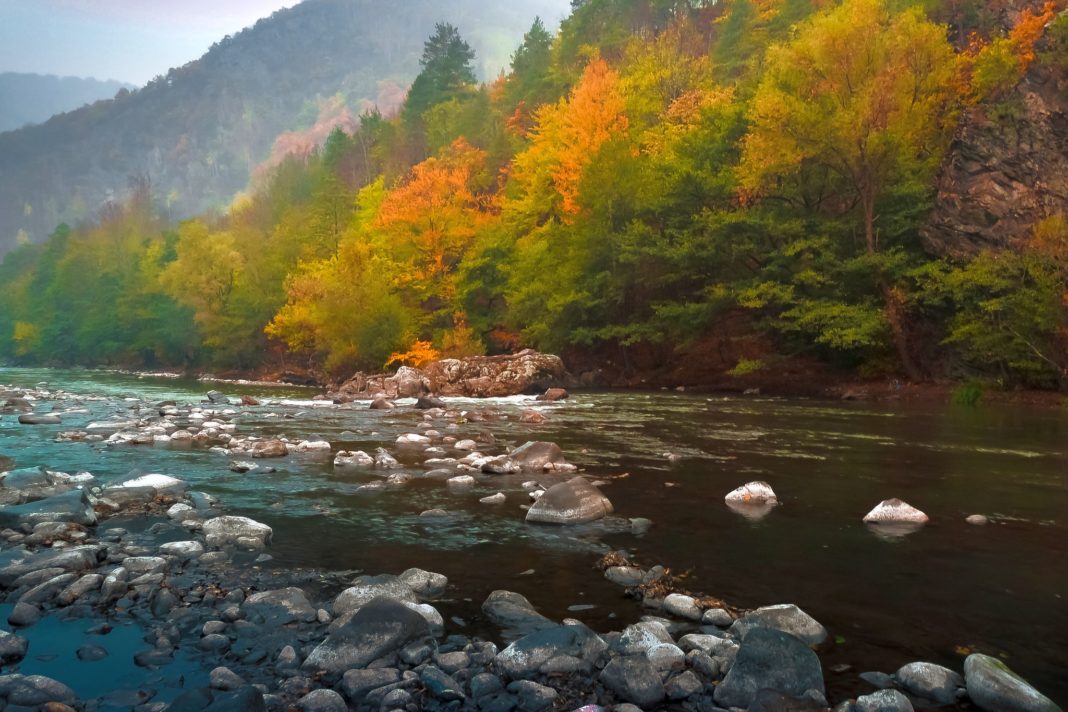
[404,22,477,118]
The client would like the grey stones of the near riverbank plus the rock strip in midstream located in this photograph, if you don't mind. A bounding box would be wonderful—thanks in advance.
[0,382,1057,712]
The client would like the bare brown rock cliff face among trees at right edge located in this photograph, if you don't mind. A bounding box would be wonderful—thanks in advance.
[923,18,1068,256]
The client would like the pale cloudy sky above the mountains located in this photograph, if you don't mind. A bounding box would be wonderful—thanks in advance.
[0,0,297,85]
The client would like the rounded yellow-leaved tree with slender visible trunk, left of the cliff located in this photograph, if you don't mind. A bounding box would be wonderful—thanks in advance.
[741,0,959,378]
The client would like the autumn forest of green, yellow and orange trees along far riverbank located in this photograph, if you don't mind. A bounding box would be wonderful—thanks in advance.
[0,0,1068,389]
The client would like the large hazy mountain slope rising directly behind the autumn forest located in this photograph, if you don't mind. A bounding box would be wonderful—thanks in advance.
[0,0,568,253]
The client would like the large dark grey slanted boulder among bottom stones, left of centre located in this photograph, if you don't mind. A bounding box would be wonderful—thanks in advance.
[301,597,430,675]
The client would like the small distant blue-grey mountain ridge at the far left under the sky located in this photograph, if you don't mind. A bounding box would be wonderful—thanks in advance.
[0,72,134,131]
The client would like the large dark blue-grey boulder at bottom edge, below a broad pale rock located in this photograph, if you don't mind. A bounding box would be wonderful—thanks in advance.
[714,628,823,708]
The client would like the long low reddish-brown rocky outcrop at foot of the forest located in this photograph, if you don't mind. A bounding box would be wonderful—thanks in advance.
[331,349,567,399]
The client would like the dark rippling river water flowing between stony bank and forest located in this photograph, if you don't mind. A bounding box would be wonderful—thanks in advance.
[0,368,1068,705]
